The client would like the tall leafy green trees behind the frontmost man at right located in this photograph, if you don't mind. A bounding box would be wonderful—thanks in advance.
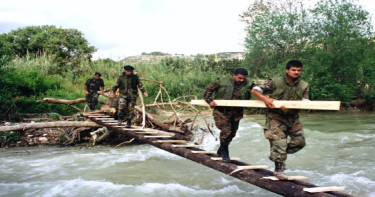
[242,0,375,101]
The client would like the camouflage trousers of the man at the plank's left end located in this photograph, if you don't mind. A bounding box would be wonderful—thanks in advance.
[213,108,243,145]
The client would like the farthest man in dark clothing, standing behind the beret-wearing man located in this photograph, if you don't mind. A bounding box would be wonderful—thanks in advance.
[85,72,104,110]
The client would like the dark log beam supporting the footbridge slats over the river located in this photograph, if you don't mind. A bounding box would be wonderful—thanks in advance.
[95,120,352,197]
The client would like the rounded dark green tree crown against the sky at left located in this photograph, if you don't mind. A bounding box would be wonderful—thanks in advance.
[0,25,96,72]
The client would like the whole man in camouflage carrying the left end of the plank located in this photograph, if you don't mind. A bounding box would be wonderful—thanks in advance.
[204,68,252,163]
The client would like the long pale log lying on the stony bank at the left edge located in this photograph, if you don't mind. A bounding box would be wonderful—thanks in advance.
[0,121,102,132]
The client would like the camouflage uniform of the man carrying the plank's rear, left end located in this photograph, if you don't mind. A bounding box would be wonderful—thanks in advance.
[204,78,252,145]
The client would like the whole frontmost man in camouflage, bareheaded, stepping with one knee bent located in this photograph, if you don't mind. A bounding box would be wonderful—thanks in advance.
[251,60,309,180]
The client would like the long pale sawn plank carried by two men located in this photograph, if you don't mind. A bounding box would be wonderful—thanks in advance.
[190,100,341,110]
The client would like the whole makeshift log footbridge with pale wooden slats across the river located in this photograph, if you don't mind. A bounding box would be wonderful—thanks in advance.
[84,113,351,197]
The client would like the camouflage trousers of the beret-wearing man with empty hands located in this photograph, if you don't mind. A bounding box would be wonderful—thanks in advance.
[117,94,137,120]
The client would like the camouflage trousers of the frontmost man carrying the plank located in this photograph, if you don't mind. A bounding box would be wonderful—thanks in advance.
[264,113,306,162]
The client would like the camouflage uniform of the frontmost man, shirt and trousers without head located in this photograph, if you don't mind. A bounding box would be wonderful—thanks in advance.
[254,75,309,162]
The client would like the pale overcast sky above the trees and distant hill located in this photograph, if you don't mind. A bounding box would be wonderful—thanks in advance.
[0,0,375,60]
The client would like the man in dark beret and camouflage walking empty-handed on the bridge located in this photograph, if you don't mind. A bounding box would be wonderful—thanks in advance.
[110,65,148,128]
